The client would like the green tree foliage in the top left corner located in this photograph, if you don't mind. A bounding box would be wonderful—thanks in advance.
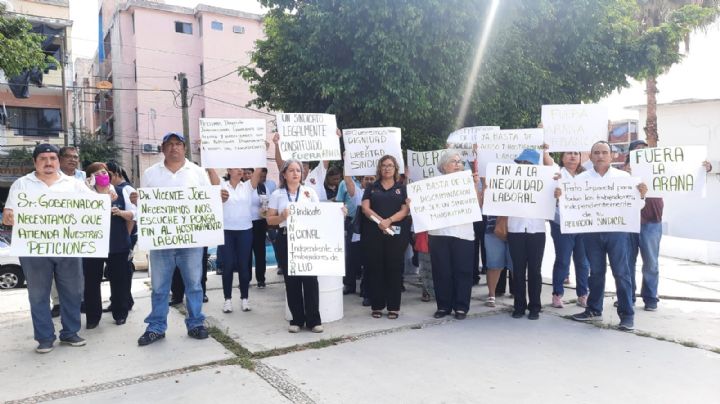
[0,5,56,77]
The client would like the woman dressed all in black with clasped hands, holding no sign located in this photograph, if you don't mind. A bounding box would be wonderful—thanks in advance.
[361,155,410,320]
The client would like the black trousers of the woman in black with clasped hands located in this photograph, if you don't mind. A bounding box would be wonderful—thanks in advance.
[360,223,408,311]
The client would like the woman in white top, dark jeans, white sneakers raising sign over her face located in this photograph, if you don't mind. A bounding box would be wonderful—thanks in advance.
[213,168,261,313]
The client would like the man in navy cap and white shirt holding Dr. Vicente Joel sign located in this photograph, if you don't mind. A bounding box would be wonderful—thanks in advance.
[130,132,210,346]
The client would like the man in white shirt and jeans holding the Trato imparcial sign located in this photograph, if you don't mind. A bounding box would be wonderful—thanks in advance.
[555,140,647,331]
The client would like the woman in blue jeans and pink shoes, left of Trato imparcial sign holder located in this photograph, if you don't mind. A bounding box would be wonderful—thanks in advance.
[550,152,590,308]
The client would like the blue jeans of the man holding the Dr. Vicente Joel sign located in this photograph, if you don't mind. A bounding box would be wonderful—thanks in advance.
[145,247,205,333]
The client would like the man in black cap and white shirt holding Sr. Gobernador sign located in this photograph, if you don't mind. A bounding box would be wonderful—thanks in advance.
[3,144,92,353]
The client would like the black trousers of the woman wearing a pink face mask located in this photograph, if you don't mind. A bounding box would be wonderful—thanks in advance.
[83,252,130,324]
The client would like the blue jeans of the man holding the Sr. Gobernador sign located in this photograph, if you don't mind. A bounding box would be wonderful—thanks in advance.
[20,257,84,342]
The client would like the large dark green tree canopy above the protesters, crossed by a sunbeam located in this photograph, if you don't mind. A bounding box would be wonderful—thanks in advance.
[241,0,716,149]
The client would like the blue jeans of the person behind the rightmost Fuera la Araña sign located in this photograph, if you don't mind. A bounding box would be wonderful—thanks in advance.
[628,223,662,304]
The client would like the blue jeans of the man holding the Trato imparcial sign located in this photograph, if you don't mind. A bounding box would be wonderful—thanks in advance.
[581,232,635,320]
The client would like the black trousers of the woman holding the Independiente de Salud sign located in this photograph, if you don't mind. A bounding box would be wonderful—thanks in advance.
[276,232,322,328]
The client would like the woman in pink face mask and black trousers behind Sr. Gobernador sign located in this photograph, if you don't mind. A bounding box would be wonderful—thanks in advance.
[83,162,135,330]
